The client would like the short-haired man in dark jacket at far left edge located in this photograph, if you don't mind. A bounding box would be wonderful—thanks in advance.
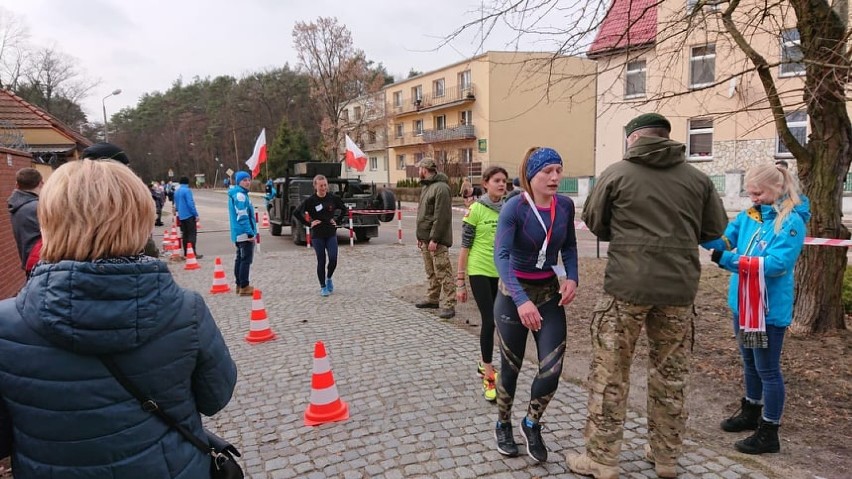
[6,168,44,277]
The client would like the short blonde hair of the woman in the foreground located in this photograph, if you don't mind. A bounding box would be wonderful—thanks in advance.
[38,160,155,263]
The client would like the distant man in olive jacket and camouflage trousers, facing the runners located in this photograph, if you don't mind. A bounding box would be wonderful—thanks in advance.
[414,158,456,319]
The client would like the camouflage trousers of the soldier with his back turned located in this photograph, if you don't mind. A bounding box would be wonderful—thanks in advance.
[585,294,695,466]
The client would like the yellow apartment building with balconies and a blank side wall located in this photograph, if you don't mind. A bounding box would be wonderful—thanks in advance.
[342,52,595,185]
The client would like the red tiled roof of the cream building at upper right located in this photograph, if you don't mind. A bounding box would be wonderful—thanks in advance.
[588,0,659,57]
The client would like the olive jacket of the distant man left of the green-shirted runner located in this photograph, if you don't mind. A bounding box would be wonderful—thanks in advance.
[416,173,453,248]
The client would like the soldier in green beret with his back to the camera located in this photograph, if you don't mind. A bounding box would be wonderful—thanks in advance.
[568,113,727,479]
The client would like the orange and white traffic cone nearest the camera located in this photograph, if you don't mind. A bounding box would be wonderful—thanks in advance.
[305,341,349,426]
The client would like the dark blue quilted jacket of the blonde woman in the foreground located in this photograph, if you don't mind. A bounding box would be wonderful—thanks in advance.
[0,260,237,479]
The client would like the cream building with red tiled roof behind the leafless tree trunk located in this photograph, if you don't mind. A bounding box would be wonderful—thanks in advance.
[588,0,836,175]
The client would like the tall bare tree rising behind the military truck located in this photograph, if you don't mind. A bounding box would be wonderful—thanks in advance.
[293,17,384,160]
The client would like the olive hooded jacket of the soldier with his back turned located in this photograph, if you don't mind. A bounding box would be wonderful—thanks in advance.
[583,137,728,306]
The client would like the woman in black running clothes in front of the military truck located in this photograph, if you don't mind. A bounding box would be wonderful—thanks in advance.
[293,175,349,297]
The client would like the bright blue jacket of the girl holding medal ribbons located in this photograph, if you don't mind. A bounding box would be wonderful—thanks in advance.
[703,196,811,327]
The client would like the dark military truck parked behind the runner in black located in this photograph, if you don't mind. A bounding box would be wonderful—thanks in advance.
[269,162,396,245]
